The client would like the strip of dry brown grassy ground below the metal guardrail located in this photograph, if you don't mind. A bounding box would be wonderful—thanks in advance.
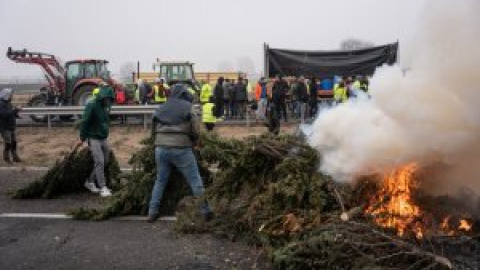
[0,125,296,167]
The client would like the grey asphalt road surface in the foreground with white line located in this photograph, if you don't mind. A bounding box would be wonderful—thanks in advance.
[0,171,271,270]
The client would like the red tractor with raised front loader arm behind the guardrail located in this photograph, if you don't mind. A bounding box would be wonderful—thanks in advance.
[7,48,127,122]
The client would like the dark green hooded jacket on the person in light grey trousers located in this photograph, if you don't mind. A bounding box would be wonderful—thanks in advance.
[80,86,115,141]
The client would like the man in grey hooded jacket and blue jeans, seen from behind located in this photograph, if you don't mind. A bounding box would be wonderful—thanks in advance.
[148,84,213,222]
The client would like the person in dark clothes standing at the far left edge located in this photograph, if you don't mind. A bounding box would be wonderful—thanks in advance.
[0,88,22,164]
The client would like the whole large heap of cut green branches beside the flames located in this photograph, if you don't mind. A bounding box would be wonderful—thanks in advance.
[176,135,480,269]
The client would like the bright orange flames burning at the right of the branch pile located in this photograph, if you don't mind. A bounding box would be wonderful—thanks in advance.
[366,164,472,239]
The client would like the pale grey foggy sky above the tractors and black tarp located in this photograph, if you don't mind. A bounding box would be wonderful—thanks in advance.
[0,0,426,78]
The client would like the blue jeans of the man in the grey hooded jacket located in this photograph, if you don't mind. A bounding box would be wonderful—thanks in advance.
[148,146,211,216]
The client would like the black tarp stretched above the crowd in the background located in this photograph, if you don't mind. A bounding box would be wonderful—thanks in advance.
[265,42,398,78]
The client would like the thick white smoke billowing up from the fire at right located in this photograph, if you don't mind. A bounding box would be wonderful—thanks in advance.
[309,0,480,192]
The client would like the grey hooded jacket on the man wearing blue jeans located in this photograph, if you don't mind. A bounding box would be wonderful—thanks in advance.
[153,84,200,148]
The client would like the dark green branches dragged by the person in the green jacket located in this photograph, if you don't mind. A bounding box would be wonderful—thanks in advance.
[11,148,120,199]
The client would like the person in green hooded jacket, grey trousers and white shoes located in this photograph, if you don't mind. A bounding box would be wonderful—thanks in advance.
[77,85,115,197]
